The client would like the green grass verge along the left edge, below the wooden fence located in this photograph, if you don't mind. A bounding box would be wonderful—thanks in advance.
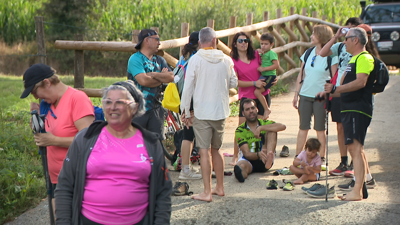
[0,75,121,224]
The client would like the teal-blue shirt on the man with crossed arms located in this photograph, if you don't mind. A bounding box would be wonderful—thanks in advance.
[127,51,170,111]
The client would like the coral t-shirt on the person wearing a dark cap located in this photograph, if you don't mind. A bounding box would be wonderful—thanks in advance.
[46,87,94,184]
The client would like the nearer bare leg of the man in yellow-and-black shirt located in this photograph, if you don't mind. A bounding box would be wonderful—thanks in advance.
[342,139,365,201]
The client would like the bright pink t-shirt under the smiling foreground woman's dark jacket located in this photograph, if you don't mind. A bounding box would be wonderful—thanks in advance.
[82,127,151,224]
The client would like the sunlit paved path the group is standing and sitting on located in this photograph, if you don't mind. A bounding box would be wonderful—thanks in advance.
[9,76,400,225]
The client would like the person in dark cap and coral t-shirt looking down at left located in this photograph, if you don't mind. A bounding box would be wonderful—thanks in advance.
[21,63,94,218]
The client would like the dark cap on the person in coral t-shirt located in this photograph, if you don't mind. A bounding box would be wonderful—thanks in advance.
[21,63,54,98]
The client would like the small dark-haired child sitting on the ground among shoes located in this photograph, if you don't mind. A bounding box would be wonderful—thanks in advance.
[289,138,321,184]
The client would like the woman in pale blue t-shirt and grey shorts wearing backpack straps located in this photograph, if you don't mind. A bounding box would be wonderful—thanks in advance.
[293,25,338,162]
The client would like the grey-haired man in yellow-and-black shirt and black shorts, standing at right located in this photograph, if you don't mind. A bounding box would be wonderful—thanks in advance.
[318,27,374,201]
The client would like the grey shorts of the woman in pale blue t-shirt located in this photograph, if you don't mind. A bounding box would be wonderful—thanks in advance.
[299,95,326,131]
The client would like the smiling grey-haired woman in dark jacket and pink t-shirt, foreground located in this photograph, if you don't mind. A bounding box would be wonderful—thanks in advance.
[56,81,172,225]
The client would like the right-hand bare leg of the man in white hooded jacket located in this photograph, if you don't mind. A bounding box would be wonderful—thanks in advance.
[211,148,225,196]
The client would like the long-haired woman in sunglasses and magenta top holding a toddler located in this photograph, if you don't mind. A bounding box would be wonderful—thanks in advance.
[229,32,277,166]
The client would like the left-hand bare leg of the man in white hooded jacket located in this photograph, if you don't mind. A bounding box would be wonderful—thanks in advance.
[192,148,212,202]
